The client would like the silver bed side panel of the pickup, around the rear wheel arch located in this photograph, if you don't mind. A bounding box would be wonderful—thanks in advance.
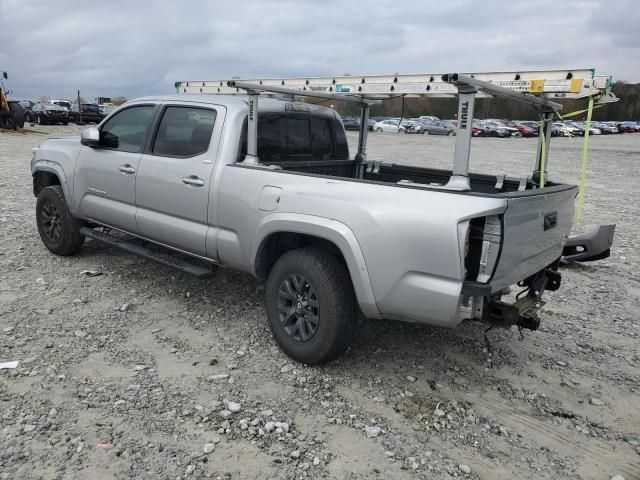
[218,165,506,325]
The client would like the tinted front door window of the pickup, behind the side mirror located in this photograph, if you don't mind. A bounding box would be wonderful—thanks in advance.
[100,105,155,153]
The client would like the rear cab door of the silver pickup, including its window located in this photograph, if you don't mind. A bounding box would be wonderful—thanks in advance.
[136,104,225,258]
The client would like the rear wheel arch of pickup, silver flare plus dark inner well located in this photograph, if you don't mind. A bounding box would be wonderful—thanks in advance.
[251,213,380,318]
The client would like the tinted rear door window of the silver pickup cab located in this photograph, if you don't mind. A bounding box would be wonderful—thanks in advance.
[153,107,216,157]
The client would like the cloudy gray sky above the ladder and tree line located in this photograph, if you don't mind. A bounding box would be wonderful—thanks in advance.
[0,0,640,99]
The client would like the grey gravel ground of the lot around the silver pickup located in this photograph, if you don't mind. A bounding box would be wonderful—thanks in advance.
[0,126,640,480]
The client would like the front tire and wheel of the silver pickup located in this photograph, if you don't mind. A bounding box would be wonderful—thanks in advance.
[36,185,85,256]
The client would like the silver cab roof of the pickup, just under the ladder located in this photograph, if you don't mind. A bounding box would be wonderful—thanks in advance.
[130,94,335,115]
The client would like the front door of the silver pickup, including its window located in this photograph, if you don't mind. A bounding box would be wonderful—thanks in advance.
[74,104,156,233]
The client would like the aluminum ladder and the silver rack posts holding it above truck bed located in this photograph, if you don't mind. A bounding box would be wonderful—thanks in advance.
[175,69,617,191]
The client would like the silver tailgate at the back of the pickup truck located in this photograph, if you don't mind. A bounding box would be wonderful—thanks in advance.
[491,185,578,292]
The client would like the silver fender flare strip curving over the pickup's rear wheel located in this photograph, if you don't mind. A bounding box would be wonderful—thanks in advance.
[249,213,382,318]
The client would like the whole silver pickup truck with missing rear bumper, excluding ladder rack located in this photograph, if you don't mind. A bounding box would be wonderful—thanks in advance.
[31,95,577,364]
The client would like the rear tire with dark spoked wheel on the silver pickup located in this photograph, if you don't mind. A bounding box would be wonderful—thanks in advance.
[265,247,355,365]
